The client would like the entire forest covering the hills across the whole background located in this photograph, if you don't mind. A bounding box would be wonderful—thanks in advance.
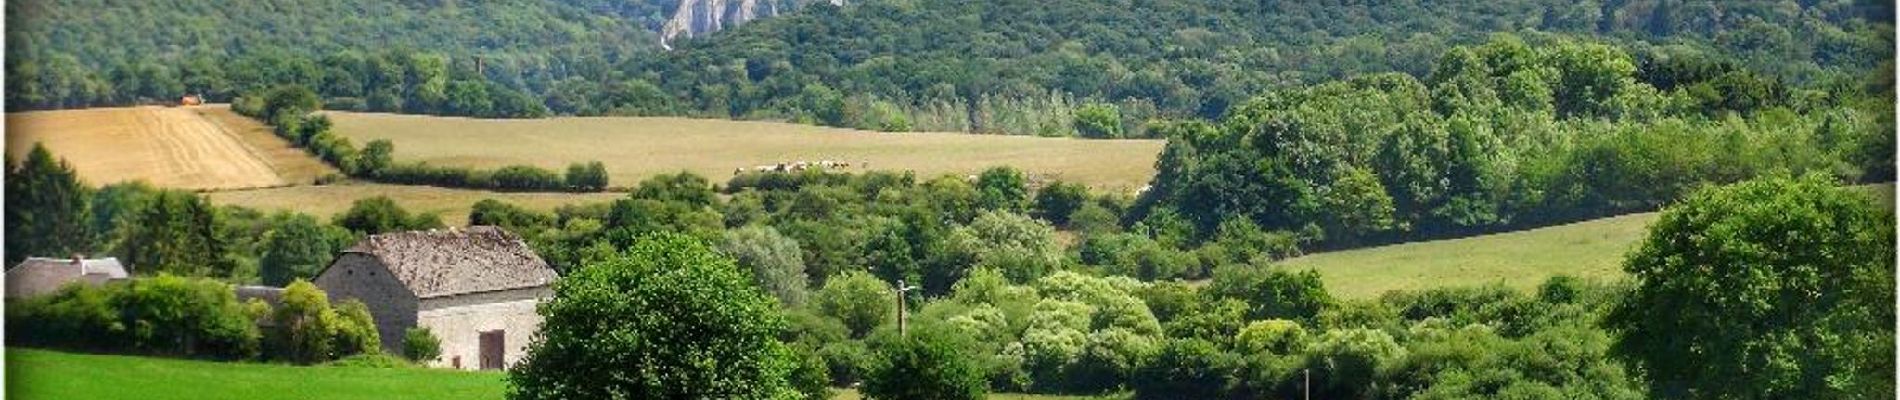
[8,0,1892,136]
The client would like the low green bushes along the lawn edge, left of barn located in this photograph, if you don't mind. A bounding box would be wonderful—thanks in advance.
[6,275,382,364]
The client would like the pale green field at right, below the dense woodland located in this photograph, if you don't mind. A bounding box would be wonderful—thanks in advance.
[1283,184,1894,298]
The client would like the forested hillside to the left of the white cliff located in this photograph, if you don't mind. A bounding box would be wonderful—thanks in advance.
[6,0,675,108]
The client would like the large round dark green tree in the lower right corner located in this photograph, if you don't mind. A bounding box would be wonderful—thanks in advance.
[1607,176,1894,398]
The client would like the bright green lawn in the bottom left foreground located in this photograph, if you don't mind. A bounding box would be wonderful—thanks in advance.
[6,347,505,400]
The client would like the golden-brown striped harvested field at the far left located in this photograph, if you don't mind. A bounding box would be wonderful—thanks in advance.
[6,106,331,190]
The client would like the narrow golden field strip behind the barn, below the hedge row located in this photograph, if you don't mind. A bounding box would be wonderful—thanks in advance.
[205,184,625,226]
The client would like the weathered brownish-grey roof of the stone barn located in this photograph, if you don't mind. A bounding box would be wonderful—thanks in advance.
[344,226,557,298]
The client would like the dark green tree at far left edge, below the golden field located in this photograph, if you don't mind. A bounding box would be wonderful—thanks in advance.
[6,142,91,265]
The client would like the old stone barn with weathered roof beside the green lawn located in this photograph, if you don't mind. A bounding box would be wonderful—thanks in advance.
[315,226,555,370]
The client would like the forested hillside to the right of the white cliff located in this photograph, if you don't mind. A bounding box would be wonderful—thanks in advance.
[629,0,1892,135]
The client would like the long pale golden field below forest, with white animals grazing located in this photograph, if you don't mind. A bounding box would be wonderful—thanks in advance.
[329,112,1163,193]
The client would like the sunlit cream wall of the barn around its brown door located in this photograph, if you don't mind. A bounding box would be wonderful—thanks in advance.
[416,286,551,370]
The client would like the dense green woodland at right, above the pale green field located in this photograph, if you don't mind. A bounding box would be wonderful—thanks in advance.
[1127,36,1894,246]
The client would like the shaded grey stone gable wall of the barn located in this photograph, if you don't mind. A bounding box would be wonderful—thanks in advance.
[315,252,420,355]
